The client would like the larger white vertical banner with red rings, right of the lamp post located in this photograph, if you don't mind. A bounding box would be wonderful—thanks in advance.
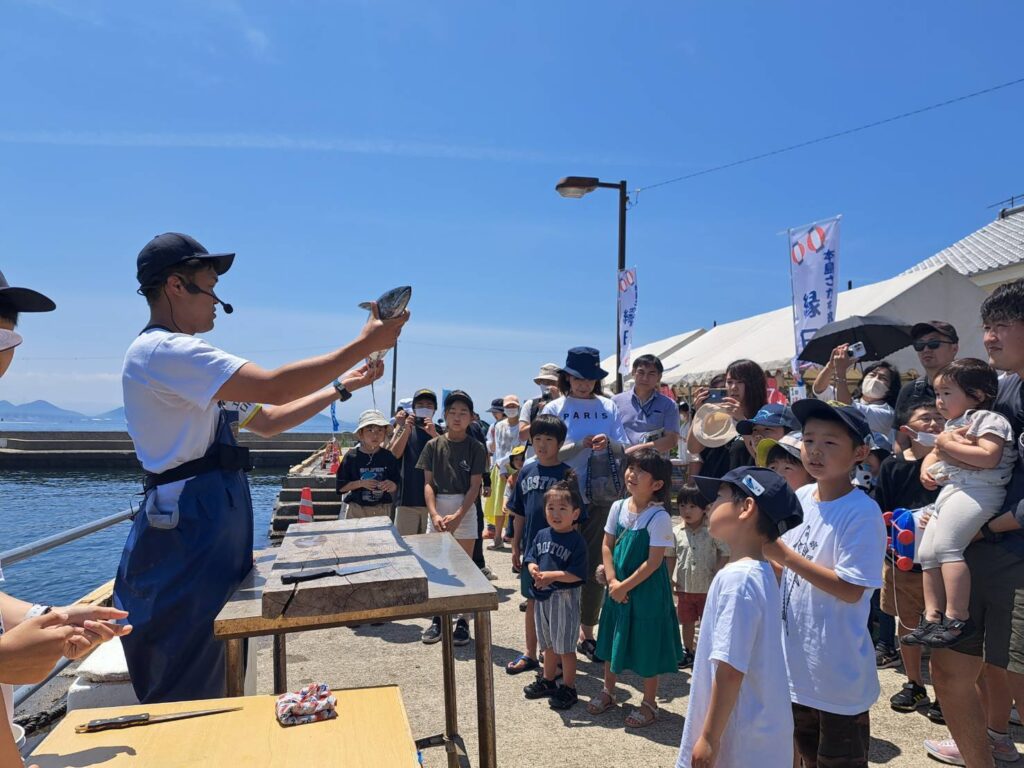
[787,216,842,383]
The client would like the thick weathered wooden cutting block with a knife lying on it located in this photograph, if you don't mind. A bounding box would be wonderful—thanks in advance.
[263,517,427,618]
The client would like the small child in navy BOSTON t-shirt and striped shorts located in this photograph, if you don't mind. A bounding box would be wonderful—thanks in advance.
[522,480,587,710]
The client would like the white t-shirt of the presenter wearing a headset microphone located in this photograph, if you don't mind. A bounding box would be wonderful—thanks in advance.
[121,328,248,511]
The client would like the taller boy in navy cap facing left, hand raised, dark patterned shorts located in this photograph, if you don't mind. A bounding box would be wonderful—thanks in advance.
[765,399,886,768]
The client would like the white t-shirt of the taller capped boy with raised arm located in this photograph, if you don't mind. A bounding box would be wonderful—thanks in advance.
[782,483,886,715]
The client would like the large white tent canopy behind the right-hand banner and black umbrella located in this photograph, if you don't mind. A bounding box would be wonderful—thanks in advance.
[662,266,987,384]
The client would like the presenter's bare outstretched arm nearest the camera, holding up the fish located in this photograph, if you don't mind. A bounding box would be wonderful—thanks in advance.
[214,304,409,406]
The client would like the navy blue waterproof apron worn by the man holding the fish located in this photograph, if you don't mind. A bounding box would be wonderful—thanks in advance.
[114,411,253,703]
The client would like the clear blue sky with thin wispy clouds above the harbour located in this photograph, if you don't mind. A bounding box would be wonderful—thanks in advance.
[0,0,1024,418]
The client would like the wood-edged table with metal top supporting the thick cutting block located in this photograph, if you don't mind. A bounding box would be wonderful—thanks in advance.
[213,534,498,768]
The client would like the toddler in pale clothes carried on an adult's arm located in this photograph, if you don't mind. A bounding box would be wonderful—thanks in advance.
[902,357,1017,648]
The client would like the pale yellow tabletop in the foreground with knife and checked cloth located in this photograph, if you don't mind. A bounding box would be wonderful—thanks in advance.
[28,685,419,768]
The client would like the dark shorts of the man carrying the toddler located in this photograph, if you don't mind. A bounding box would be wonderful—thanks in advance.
[950,542,1024,674]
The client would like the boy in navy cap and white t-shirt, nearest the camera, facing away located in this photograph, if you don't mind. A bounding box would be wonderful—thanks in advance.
[676,467,803,768]
